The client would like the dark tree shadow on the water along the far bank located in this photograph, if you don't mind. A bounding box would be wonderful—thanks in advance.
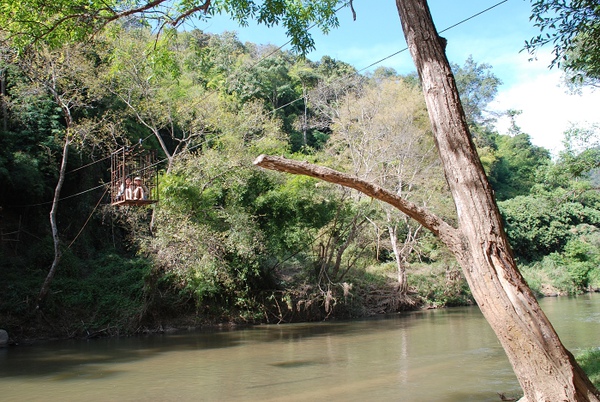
[0,310,440,381]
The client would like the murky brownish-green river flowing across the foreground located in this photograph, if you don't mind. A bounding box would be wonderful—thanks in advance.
[0,294,600,402]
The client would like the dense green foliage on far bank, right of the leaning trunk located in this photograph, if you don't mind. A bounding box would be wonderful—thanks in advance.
[499,129,600,294]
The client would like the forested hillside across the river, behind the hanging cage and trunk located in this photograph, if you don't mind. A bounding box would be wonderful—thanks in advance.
[0,24,600,337]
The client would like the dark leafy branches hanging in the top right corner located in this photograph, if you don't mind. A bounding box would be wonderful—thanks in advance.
[525,0,600,85]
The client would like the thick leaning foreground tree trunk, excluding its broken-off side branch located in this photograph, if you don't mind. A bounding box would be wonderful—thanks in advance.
[396,0,600,401]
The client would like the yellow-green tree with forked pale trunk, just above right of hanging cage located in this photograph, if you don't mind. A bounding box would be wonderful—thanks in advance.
[103,28,217,172]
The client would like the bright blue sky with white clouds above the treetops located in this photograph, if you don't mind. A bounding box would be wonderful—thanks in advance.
[195,0,600,155]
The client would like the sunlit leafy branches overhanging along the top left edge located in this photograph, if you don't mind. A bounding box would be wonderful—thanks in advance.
[0,0,347,53]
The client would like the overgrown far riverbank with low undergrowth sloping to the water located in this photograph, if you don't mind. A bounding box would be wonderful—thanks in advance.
[0,254,596,343]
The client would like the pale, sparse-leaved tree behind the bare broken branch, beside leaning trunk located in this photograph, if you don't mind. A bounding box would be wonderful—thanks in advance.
[328,77,442,294]
